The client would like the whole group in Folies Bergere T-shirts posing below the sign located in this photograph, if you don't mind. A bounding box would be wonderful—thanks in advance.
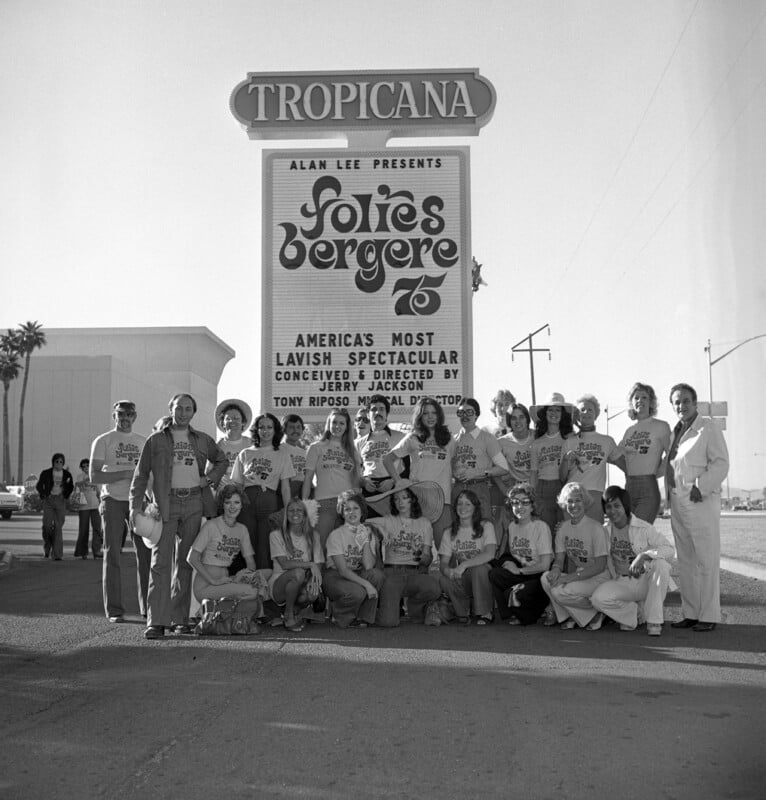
[51,383,728,639]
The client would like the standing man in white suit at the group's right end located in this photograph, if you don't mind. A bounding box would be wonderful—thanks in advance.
[665,383,729,632]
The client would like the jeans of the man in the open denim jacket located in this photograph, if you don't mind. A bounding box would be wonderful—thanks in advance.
[148,494,202,628]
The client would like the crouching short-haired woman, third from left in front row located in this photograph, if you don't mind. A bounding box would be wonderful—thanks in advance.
[322,490,383,628]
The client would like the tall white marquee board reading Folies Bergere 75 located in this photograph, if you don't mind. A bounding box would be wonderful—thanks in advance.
[261,147,473,421]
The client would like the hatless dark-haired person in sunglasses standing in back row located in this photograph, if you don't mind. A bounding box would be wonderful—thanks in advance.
[452,397,508,520]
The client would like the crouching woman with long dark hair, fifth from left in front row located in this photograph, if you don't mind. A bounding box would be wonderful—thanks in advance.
[439,489,497,625]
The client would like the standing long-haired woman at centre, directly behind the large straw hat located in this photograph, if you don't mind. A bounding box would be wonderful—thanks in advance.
[383,397,455,548]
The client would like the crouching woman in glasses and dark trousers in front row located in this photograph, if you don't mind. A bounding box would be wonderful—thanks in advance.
[489,483,553,625]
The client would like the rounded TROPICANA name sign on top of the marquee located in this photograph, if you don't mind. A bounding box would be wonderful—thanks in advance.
[230,69,495,139]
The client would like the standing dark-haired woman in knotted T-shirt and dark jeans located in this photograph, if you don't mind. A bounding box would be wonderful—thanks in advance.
[231,414,295,569]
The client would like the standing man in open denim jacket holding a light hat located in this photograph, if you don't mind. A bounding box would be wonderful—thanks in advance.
[130,394,228,639]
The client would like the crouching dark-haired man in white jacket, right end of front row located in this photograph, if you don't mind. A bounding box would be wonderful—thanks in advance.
[590,486,675,636]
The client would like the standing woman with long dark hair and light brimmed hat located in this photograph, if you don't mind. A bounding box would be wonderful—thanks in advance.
[529,392,574,532]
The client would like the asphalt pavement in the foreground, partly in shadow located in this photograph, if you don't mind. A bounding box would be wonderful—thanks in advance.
[0,518,766,800]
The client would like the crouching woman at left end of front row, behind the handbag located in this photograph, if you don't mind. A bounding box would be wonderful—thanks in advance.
[187,484,259,602]
